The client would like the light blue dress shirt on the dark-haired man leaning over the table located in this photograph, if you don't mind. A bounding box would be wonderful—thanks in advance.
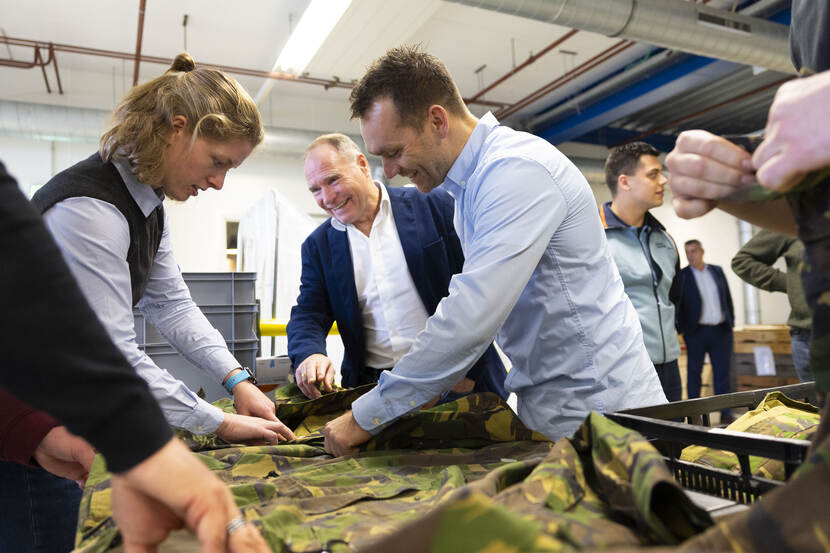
[352,113,666,440]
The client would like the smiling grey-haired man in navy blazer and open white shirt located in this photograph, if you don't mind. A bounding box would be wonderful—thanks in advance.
[287,134,507,398]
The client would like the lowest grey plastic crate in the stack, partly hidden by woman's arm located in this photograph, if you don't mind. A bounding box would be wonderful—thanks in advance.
[142,340,258,402]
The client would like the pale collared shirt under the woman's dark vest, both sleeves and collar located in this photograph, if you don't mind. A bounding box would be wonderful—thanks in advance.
[44,155,239,434]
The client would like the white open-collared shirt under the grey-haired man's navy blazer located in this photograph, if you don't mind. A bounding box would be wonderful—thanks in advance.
[331,182,429,369]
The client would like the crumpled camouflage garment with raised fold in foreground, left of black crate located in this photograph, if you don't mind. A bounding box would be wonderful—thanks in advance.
[361,413,711,553]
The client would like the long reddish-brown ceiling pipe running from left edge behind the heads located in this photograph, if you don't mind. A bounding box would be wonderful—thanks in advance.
[0,36,509,109]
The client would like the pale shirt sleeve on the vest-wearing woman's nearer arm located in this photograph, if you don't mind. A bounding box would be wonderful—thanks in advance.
[44,197,227,434]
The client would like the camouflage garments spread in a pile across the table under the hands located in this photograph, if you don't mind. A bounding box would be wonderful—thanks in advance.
[76,385,711,553]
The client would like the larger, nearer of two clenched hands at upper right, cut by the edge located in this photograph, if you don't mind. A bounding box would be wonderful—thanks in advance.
[752,71,830,191]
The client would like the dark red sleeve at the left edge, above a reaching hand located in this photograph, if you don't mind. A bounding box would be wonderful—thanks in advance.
[0,388,60,465]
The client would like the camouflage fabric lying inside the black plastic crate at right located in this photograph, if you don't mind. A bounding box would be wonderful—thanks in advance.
[680,392,819,481]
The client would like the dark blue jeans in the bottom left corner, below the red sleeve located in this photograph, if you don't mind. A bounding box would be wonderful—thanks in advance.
[0,461,81,553]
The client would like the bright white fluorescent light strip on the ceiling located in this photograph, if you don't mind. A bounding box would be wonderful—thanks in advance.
[256,0,352,103]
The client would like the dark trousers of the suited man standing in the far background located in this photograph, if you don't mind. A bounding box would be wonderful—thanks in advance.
[683,323,733,399]
